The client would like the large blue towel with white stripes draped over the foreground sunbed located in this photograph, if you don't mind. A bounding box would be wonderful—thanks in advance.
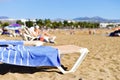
[0,45,60,67]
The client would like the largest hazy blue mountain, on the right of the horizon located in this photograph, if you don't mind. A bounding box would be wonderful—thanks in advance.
[73,16,120,23]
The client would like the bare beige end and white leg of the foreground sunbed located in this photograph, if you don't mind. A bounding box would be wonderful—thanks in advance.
[54,45,89,74]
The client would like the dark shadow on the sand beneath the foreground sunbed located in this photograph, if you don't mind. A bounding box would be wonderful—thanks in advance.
[0,64,61,75]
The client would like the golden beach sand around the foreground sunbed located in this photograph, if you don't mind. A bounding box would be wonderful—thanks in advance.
[0,29,120,80]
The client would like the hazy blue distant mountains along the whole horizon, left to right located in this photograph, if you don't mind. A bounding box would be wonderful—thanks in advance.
[0,16,120,23]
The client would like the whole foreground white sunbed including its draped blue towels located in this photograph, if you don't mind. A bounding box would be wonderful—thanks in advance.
[0,41,89,74]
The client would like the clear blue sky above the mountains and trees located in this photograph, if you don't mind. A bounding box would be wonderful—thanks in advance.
[0,0,120,19]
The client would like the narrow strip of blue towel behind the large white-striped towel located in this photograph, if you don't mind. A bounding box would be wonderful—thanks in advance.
[0,40,23,45]
